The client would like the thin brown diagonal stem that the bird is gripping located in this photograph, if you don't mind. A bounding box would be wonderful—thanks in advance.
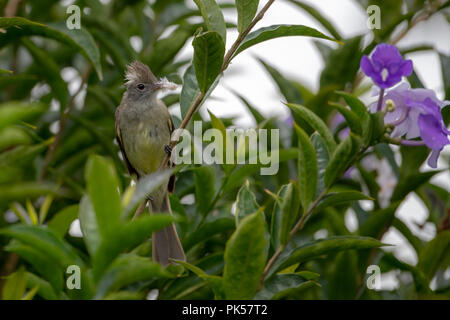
[159,0,275,170]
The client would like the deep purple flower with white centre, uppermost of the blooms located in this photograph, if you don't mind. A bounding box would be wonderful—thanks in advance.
[361,43,413,89]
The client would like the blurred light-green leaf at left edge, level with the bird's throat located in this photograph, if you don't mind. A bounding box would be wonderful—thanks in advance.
[0,100,46,129]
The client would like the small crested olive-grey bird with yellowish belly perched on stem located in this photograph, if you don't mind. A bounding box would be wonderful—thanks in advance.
[115,61,186,265]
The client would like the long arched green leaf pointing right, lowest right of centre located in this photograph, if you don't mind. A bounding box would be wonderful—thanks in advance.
[268,236,383,277]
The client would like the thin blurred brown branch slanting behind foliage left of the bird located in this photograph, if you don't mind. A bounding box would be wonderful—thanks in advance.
[39,66,92,180]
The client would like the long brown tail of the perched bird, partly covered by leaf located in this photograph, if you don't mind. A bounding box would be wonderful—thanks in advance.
[152,193,186,266]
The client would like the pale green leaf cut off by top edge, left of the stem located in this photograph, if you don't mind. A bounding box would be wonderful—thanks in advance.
[194,0,227,43]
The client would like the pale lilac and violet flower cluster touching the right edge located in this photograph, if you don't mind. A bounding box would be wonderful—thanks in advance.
[370,84,450,168]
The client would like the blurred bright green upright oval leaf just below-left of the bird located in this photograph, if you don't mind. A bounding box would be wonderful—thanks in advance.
[86,155,121,235]
